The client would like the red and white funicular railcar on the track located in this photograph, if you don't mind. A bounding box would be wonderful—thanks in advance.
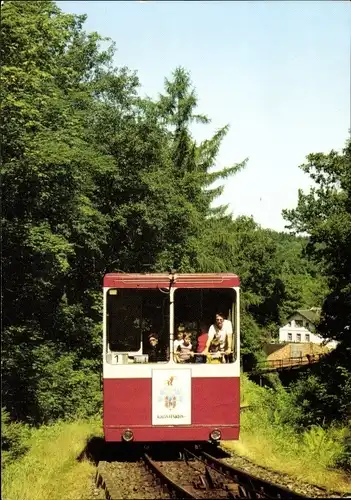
[103,273,240,443]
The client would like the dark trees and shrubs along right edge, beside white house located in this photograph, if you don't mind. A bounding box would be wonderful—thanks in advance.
[283,139,351,424]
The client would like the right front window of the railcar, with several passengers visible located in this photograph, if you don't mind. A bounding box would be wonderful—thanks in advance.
[173,288,237,364]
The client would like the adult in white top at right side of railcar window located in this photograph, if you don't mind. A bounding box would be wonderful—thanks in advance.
[202,312,233,362]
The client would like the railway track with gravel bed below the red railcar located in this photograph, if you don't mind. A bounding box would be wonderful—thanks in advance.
[96,448,307,500]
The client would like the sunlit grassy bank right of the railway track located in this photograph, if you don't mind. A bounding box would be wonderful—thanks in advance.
[223,376,351,493]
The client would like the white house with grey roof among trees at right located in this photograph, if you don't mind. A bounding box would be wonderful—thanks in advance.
[279,307,337,349]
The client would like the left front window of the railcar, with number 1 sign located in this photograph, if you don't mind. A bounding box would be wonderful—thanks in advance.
[106,289,169,364]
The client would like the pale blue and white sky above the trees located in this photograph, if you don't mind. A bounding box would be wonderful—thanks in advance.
[57,0,351,231]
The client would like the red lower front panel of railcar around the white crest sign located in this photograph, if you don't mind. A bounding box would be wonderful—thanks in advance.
[104,377,240,442]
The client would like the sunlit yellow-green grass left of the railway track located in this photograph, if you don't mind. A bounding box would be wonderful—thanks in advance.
[2,419,102,500]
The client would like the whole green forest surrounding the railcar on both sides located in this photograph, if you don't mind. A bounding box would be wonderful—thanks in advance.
[0,0,351,472]
